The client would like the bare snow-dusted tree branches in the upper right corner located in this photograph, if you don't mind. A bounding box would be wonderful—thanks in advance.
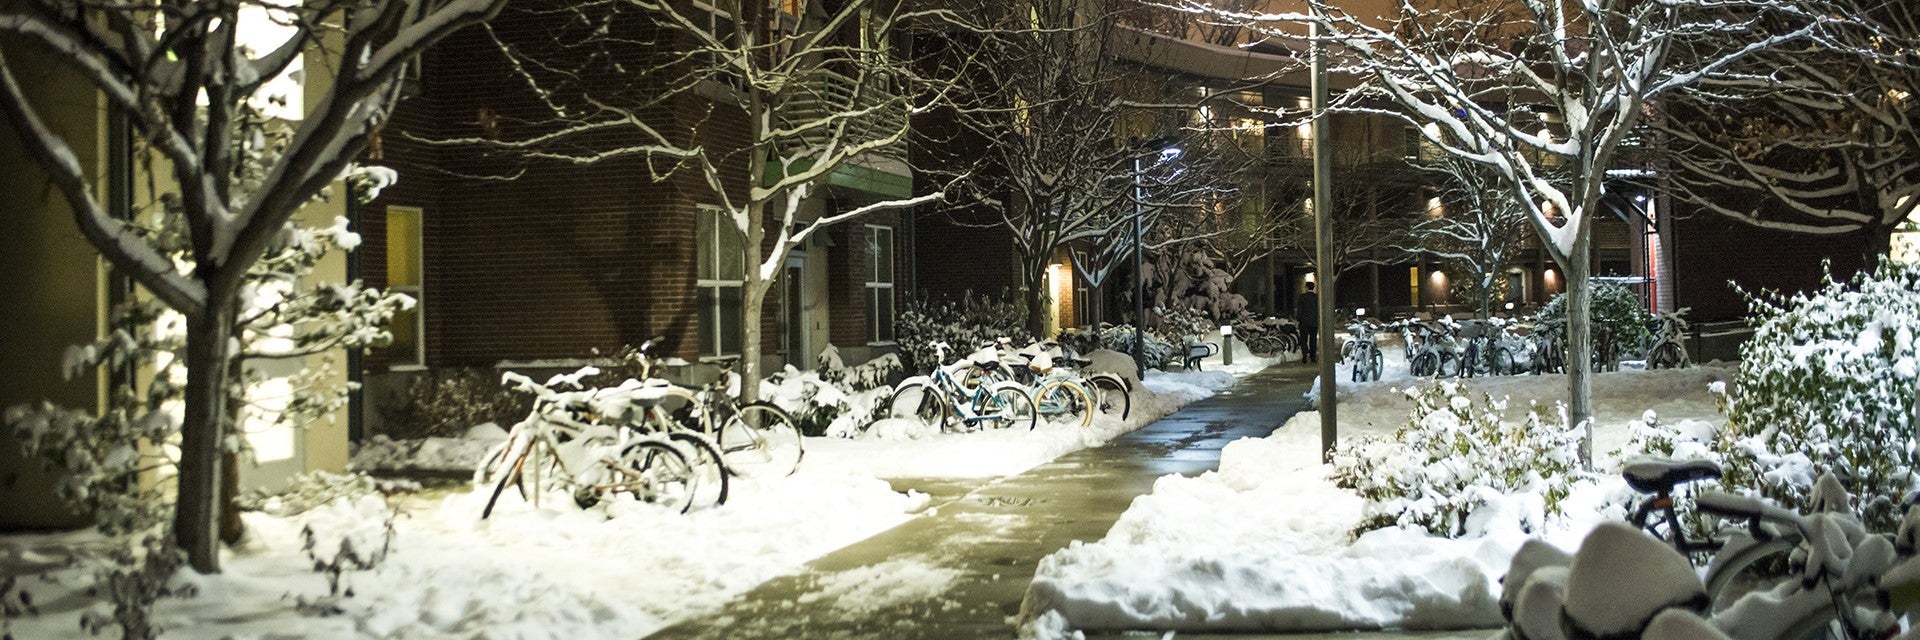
[1653,0,1920,265]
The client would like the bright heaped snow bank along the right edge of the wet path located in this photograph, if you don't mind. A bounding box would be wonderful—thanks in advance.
[1021,417,1523,638]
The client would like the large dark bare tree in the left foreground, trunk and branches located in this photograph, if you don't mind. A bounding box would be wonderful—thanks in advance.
[0,0,505,573]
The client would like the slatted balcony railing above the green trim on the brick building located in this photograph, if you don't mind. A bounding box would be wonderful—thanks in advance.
[781,71,906,161]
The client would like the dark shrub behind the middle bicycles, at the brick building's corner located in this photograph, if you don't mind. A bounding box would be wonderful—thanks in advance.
[893,292,1033,375]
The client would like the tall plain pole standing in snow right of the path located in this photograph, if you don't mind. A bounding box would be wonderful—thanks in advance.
[1309,2,1340,461]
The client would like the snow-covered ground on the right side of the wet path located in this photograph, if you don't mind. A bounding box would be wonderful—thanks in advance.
[1023,361,1732,638]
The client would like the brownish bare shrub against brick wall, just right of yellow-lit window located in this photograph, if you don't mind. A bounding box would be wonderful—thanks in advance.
[382,367,534,440]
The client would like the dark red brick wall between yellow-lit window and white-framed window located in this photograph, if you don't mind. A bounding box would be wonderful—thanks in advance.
[361,8,780,367]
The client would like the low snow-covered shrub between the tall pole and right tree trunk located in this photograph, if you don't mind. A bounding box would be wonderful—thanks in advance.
[1332,382,1582,538]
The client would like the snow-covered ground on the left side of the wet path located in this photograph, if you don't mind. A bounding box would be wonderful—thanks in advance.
[0,359,1271,638]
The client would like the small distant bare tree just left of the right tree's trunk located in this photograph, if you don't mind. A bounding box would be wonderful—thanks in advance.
[1405,156,1530,317]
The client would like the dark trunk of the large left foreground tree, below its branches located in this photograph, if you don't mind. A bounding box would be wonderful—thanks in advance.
[173,286,234,573]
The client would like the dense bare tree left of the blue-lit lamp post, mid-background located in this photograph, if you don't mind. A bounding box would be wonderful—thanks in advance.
[943,0,1223,332]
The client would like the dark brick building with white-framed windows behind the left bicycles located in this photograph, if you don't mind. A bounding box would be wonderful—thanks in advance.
[355,2,912,430]
